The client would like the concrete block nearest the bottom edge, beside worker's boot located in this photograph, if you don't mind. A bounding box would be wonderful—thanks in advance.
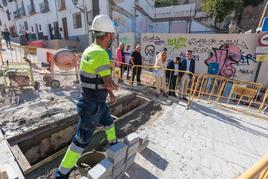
[87,159,113,179]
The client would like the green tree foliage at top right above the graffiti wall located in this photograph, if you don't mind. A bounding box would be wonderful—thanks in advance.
[203,0,243,23]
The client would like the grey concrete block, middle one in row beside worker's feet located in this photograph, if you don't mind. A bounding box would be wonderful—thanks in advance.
[106,142,127,165]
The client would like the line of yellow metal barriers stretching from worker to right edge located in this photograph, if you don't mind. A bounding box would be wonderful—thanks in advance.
[109,61,268,115]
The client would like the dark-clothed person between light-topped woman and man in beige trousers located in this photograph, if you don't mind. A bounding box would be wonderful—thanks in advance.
[166,57,181,97]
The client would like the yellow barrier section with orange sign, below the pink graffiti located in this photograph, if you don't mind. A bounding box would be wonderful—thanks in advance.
[191,74,268,118]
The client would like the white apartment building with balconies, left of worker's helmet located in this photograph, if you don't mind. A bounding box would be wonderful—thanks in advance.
[0,0,109,47]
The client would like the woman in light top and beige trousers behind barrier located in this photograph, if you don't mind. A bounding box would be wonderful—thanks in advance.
[154,51,168,97]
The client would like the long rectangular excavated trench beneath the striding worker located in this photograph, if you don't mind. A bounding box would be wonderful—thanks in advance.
[8,94,161,178]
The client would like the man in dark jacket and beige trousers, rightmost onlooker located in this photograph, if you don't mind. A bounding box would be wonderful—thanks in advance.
[181,50,195,101]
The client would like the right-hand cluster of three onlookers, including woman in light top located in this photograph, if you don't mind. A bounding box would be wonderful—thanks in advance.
[154,48,195,101]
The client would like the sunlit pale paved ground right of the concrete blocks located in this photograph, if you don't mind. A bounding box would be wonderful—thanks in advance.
[125,102,268,179]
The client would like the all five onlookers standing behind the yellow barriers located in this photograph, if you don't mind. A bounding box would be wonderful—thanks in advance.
[116,42,195,101]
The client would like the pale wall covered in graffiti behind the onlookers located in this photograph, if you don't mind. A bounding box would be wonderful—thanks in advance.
[141,33,258,81]
